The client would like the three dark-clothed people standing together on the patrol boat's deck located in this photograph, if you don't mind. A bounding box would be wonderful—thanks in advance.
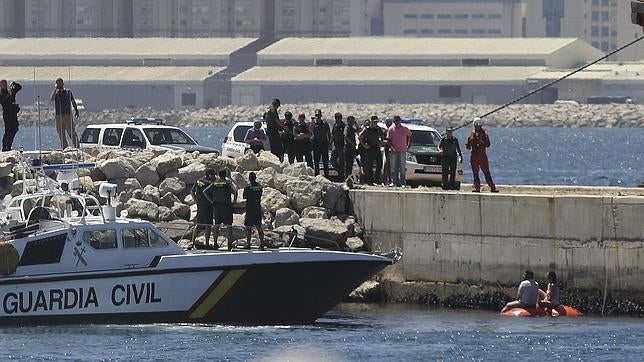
[191,169,267,250]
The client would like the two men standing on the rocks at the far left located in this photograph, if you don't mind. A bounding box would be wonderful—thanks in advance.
[0,78,79,152]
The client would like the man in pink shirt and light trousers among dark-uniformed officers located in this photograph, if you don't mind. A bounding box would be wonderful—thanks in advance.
[387,116,411,187]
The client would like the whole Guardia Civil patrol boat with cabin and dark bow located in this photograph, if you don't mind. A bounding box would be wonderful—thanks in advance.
[0,158,400,326]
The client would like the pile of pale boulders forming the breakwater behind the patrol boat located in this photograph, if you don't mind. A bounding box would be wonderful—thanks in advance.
[0,150,365,250]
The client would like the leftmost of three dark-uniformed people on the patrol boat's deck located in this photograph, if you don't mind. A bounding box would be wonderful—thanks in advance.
[190,169,217,249]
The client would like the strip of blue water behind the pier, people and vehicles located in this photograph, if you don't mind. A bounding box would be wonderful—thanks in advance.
[14,127,644,187]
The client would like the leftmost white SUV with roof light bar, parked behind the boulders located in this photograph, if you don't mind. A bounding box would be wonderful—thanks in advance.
[80,118,219,153]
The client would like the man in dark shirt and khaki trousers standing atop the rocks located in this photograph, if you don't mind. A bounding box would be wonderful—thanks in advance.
[49,78,78,149]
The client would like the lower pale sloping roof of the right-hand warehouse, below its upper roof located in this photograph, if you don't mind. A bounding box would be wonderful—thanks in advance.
[232,66,545,85]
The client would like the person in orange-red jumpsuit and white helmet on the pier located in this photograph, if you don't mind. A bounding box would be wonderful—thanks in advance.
[465,117,499,192]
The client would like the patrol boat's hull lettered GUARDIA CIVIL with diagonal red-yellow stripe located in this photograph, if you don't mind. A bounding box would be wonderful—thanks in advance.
[0,256,391,325]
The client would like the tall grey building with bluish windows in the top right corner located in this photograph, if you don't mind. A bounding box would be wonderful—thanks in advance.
[526,0,644,60]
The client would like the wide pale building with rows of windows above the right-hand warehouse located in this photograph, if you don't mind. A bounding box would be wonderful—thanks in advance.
[383,0,532,38]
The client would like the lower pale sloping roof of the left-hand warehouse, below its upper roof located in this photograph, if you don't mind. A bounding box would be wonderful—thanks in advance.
[2,67,223,84]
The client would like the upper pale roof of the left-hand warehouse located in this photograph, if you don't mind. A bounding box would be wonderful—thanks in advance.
[0,38,255,59]
